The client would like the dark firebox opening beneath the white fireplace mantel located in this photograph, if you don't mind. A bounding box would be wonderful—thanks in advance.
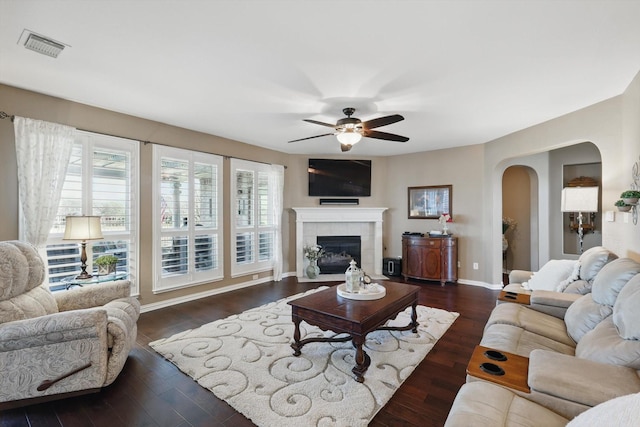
[316,236,362,274]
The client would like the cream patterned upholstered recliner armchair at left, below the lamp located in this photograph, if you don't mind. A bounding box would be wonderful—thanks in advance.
[0,241,140,410]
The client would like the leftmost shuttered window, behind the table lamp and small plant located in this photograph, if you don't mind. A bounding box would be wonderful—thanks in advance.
[47,131,139,293]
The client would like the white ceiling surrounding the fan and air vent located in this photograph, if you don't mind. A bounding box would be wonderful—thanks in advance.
[0,0,640,156]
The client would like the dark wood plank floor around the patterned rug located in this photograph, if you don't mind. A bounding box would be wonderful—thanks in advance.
[0,278,498,427]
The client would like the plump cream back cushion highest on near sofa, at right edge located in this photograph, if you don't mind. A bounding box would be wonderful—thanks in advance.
[591,258,640,307]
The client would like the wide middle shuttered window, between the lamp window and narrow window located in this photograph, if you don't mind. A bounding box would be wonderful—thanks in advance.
[153,146,223,292]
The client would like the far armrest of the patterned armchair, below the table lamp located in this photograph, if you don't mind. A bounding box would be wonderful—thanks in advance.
[53,280,131,311]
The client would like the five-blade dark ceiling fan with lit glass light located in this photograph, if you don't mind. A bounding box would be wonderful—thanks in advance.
[289,107,409,152]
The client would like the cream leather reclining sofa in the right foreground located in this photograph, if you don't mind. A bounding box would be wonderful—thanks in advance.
[446,252,640,427]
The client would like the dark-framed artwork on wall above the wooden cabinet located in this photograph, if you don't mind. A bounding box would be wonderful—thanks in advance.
[408,185,453,219]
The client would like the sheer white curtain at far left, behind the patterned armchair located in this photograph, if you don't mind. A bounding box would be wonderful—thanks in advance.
[13,116,75,251]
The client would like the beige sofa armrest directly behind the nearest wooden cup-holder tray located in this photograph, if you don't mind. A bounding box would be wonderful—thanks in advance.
[528,350,640,406]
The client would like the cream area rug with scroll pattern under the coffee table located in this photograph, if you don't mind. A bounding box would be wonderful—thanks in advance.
[149,287,458,427]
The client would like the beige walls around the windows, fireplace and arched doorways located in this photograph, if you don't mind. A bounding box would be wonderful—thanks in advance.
[0,70,640,298]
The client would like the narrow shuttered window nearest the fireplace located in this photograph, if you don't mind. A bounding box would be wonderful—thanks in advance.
[231,159,275,276]
